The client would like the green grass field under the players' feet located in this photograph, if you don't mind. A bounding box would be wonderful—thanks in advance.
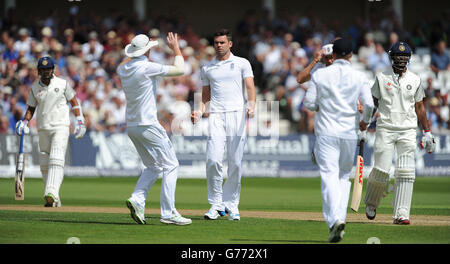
[0,177,450,244]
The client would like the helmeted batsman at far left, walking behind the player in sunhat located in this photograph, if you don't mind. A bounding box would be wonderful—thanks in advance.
[16,57,86,207]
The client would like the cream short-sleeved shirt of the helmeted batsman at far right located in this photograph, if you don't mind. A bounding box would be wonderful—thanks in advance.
[372,69,425,130]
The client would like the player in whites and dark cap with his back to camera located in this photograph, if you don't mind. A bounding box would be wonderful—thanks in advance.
[304,39,374,242]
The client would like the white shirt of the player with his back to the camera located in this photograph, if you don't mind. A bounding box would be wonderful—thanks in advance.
[304,59,374,139]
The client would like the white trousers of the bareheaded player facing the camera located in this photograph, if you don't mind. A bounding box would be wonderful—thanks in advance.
[206,111,247,213]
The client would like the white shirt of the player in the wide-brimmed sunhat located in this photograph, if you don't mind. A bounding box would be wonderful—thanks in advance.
[117,55,169,126]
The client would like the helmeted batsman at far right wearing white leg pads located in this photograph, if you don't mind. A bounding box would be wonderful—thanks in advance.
[364,42,436,225]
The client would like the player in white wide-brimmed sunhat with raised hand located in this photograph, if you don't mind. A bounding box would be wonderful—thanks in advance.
[117,32,192,225]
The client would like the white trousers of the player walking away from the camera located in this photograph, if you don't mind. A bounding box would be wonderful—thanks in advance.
[314,136,357,228]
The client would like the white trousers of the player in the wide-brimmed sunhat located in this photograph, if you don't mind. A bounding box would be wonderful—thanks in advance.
[128,123,179,218]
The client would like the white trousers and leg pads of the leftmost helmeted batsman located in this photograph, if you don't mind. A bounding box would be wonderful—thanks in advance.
[38,126,70,200]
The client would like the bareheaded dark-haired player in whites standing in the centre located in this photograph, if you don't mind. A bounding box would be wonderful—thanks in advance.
[191,29,256,220]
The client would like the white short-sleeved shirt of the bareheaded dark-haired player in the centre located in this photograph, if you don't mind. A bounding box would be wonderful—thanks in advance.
[201,54,253,113]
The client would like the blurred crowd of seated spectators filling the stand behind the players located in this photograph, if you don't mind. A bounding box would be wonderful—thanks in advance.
[0,8,450,136]
